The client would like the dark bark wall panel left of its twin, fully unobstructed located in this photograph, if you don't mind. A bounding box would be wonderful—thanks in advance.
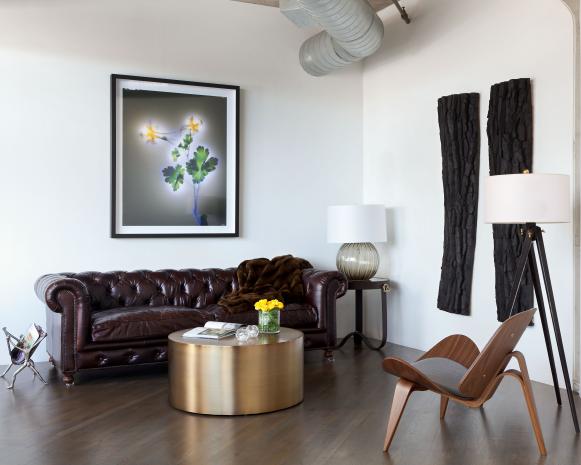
[438,94,480,315]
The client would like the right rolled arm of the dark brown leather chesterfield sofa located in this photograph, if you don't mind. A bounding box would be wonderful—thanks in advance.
[303,268,347,338]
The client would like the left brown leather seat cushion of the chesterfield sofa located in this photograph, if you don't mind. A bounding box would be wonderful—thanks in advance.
[91,306,207,342]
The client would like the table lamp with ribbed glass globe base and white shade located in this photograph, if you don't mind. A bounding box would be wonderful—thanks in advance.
[327,205,387,280]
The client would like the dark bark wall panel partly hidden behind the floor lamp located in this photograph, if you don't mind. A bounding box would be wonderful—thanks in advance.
[486,79,533,321]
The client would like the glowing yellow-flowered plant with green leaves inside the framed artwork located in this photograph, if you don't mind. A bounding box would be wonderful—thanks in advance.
[142,116,218,226]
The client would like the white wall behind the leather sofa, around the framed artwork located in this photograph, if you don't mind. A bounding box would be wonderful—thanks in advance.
[0,0,362,364]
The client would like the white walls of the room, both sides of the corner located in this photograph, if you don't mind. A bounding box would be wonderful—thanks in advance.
[0,0,573,381]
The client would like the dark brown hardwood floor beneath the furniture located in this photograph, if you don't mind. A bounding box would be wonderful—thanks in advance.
[0,344,581,465]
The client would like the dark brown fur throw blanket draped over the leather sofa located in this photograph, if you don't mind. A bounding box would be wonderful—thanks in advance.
[218,255,313,313]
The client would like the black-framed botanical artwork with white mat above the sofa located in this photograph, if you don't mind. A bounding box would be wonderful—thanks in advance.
[111,74,240,238]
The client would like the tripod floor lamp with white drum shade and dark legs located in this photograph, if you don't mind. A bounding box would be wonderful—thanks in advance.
[485,172,579,433]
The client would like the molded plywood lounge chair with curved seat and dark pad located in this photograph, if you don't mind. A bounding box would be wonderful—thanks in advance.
[383,308,547,455]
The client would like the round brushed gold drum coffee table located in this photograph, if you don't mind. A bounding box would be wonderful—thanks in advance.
[168,328,304,415]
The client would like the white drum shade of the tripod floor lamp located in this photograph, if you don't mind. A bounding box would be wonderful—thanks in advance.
[484,173,571,224]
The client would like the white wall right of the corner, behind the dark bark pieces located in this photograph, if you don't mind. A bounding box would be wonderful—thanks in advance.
[363,0,574,382]
